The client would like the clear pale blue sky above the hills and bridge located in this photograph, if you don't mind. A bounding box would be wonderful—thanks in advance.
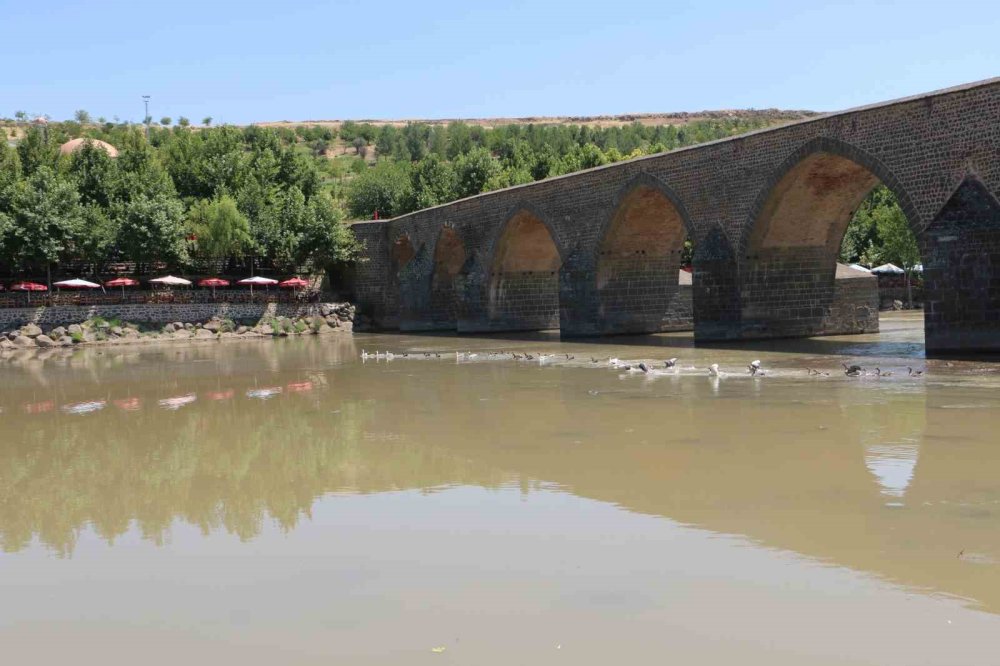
[0,0,1000,123]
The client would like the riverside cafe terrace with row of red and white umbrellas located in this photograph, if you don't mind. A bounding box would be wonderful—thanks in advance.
[0,274,322,308]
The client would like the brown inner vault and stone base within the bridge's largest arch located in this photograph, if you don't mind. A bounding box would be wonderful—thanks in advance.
[742,151,916,337]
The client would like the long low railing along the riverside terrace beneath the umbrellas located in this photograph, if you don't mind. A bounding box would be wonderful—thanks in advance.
[0,287,321,308]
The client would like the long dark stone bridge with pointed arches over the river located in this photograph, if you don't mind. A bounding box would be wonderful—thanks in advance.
[353,79,1000,353]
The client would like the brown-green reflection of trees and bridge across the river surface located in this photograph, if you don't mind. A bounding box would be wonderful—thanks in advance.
[0,322,1000,663]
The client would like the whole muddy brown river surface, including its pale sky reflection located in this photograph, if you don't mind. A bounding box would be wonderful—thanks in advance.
[0,315,1000,665]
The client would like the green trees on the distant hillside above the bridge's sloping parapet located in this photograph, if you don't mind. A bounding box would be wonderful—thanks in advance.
[340,117,769,219]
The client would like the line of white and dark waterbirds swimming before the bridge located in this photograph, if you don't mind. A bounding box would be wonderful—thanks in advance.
[361,349,924,379]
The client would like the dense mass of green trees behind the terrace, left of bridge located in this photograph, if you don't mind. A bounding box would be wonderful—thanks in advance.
[0,123,357,274]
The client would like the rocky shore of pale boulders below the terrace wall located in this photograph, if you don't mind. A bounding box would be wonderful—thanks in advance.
[0,303,355,352]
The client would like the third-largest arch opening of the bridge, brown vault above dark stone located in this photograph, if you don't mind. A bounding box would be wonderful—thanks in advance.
[489,210,562,331]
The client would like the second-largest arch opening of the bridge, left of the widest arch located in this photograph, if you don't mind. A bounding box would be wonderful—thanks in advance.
[597,185,692,333]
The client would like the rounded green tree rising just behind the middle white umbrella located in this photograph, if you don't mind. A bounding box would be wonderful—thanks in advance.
[116,194,188,270]
